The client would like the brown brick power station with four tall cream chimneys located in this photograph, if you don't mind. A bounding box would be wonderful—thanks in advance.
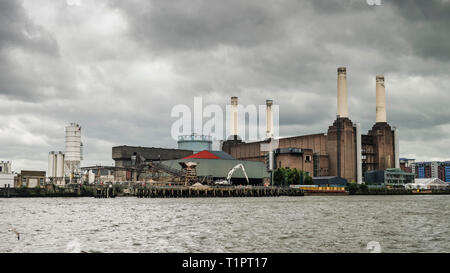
[222,67,400,183]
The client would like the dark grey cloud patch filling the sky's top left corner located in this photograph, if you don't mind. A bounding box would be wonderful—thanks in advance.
[0,0,67,101]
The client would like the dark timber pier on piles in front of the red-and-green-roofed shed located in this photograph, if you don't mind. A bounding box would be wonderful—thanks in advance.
[134,186,304,198]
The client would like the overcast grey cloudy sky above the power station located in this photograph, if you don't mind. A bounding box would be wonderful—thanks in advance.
[0,0,450,171]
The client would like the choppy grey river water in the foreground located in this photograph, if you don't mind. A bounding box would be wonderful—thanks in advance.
[0,195,450,252]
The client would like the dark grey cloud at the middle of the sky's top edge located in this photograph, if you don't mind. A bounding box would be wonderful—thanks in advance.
[114,0,285,51]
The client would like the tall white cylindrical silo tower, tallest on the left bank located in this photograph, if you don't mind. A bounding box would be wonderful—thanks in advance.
[64,123,83,179]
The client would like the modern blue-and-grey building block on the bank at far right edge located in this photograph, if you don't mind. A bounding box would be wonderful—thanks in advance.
[411,161,450,182]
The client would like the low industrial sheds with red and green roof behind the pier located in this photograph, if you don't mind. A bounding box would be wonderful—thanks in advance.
[108,143,270,185]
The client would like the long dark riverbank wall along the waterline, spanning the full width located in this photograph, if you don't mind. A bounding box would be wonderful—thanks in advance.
[0,185,450,198]
